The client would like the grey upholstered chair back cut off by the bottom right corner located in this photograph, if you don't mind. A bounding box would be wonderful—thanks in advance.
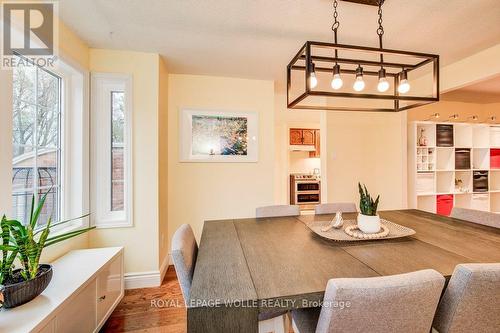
[433,263,500,333]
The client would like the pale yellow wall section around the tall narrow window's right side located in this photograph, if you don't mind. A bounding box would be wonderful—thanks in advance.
[89,49,160,273]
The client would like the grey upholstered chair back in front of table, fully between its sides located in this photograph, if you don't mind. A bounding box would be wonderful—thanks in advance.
[316,269,445,333]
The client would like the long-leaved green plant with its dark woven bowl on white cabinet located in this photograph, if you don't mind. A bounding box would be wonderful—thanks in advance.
[0,190,95,308]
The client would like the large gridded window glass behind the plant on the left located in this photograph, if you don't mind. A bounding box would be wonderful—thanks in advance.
[12,57,62,226]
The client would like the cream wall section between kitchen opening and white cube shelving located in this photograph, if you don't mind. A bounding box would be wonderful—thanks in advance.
[326,112,407,209]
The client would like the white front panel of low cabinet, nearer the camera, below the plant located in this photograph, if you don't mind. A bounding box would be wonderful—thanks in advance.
[56,280,96,333]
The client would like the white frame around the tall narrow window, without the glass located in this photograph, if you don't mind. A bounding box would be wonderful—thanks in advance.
[91,73,133,228]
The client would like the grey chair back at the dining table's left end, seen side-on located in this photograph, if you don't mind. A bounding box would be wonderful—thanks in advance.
[172,224,198,302]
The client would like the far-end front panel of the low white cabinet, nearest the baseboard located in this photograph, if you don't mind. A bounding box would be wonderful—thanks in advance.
[96,254,123,326]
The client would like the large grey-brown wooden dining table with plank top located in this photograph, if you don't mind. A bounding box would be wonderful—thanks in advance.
[187,210,500,333]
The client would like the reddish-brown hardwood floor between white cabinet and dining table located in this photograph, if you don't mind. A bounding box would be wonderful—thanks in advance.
[100,266,293,333]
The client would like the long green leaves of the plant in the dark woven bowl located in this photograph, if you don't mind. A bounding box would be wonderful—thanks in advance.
[0,190,95,284]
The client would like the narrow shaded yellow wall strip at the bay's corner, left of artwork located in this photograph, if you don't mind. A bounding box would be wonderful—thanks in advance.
[158,58,169,267]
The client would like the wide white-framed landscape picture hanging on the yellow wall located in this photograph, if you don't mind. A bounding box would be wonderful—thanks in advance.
[179,109,258,163]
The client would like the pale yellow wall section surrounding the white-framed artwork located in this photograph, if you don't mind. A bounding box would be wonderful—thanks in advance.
[168,74,274,239]
